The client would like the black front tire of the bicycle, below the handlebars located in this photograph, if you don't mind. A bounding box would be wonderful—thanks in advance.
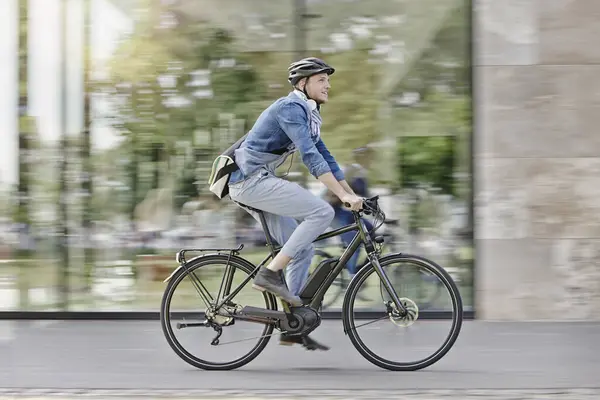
[342,253,463,371]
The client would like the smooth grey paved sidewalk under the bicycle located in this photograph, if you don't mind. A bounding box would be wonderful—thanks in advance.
[0,321,600,400]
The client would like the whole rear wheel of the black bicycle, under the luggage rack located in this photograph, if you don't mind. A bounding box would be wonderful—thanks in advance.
[160,255,277,370]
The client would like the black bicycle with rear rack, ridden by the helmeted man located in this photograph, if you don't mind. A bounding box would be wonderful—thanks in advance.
[160,196,463,371]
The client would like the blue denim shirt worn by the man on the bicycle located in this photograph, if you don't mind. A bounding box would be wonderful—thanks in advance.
[229,92,344,185]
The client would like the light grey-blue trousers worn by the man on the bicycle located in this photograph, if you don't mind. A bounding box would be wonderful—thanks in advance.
[229,167,334,295]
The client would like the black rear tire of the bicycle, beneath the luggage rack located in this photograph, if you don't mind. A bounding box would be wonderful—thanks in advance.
[160,254,277,371]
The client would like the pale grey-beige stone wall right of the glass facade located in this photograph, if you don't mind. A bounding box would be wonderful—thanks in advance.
[473,0,600,320]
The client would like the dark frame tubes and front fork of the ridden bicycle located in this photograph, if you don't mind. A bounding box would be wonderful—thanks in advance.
[215,205,406,315]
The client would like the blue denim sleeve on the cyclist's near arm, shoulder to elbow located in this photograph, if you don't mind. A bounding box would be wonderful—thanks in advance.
[277,102,331,178]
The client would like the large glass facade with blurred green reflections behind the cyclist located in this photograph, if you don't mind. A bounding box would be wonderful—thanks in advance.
[0,0,474,312]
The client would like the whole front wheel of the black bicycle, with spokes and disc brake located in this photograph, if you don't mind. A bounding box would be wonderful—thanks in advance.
[343,254,463,371]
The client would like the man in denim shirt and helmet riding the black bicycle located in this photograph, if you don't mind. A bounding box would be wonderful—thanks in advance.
[229,57,362,350]
